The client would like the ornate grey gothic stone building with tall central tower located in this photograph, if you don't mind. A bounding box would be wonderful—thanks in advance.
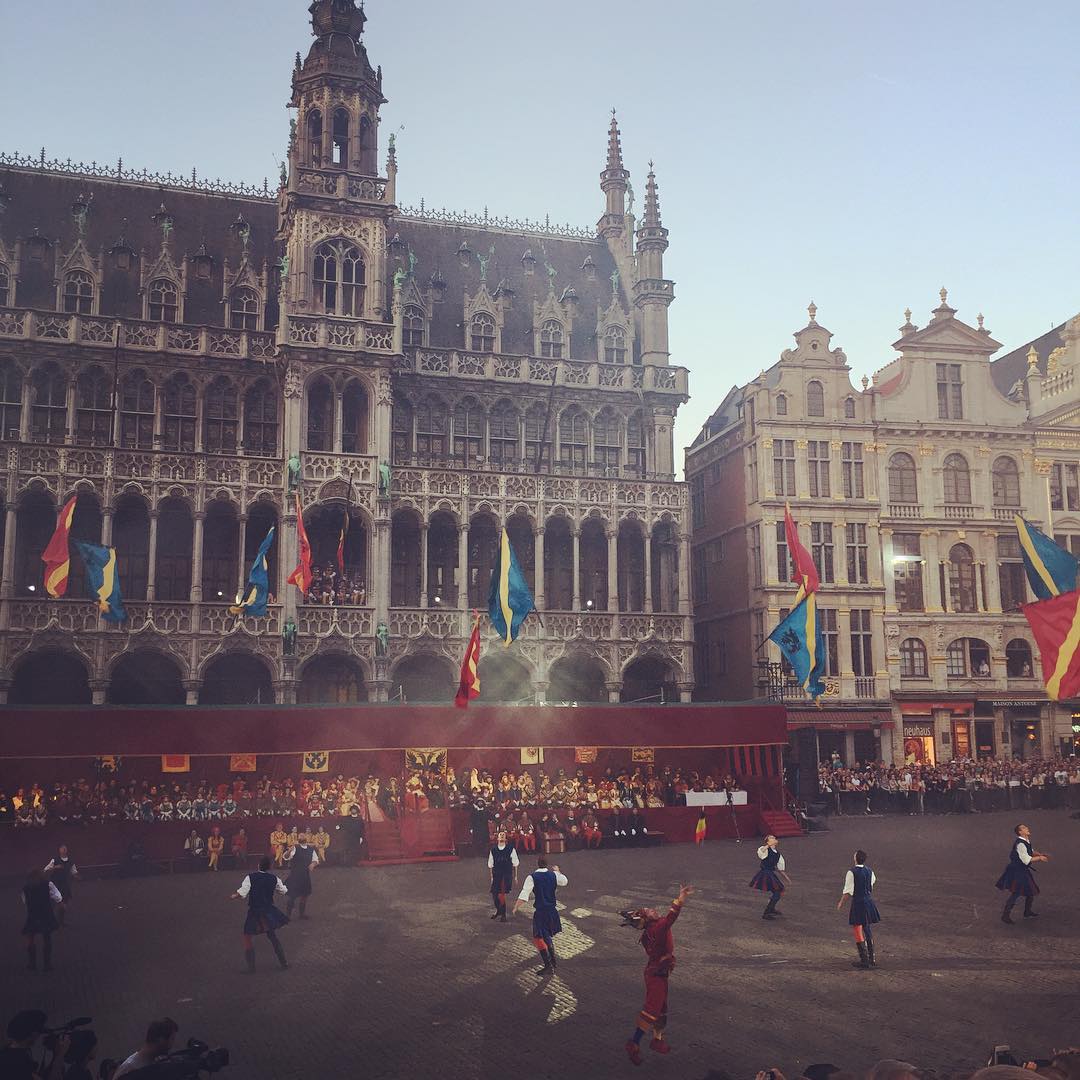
[0,0,692,703]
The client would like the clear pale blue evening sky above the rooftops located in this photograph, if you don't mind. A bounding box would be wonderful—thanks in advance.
[0,0,1080,468]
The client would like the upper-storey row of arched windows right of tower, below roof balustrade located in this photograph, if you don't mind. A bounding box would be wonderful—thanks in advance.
[392,393,650,475]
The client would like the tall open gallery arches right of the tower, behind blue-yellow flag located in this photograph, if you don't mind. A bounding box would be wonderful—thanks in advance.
[390,509,680,612]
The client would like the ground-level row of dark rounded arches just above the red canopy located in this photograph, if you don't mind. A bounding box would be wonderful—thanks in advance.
[8,649,678,705]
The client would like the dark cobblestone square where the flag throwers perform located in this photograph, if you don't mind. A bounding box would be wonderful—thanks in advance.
[0,811,1080,1080]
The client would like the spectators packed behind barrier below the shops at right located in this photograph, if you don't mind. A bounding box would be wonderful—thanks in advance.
[818,754,1080,814]
